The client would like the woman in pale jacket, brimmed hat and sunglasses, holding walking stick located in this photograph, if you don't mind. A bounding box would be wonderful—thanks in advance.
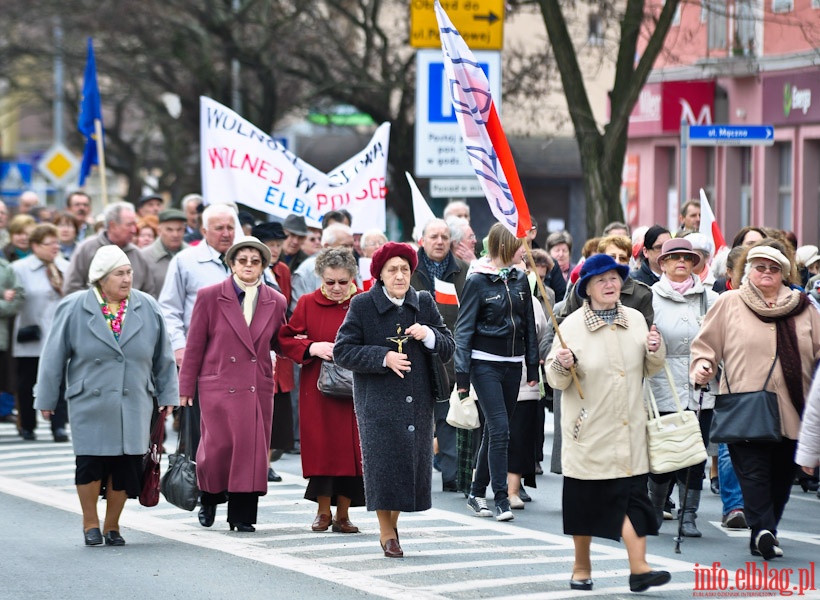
[649,238,718,537]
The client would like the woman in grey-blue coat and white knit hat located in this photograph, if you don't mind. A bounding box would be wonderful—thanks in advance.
[34,245,179,546]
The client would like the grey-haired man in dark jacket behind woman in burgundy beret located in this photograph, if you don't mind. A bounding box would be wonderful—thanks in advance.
[410,219,469,492]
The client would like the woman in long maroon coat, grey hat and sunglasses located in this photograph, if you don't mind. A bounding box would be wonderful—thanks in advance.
[179,236,287,532]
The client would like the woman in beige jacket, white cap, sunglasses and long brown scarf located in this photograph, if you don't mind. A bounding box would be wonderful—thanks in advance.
[690,239,820,560]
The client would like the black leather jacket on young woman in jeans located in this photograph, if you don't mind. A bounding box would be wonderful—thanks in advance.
[455,269,538,389]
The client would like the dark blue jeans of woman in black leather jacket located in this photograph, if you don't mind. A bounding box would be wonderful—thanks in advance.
[470,360,523,502]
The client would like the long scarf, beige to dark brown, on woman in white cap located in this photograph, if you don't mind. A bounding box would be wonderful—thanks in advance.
[740,282,809,418]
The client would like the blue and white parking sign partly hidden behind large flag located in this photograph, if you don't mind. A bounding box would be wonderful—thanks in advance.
[415,50,501,177]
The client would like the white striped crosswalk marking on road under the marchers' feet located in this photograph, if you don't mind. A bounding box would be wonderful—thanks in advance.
[0,425,692,600]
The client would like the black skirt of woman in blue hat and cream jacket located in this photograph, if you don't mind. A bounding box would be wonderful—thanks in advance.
[563,475,658,542]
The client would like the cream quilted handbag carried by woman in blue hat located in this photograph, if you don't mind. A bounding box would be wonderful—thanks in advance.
[646,364,706,474]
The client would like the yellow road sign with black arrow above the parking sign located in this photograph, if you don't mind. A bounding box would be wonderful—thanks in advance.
[410,0,504,50]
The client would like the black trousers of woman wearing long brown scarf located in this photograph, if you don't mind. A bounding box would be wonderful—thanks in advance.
[728,438,797,542]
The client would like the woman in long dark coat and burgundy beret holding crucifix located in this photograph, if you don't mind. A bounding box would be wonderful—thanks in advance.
[333,242,455,558]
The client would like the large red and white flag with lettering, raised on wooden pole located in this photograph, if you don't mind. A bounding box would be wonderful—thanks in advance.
[435,0,532,238]
